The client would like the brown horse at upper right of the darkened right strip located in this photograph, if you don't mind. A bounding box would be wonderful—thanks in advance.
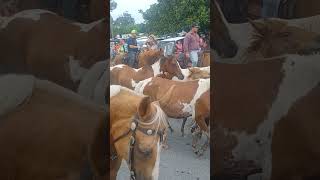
[246,19,320,61]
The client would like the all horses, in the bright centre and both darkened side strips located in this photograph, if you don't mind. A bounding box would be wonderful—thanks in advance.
[0,1,320,180]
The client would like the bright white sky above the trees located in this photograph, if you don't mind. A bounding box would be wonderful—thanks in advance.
[111,0,158,24]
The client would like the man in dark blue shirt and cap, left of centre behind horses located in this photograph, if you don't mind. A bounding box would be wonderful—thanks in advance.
[127,30,139,68]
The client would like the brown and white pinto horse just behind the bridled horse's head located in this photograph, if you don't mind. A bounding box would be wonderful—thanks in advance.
[135,77,210,140]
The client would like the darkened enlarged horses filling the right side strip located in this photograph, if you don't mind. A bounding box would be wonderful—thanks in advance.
[210,1,320,180]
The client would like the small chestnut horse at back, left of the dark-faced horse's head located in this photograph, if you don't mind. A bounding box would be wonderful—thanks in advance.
[137,49,164,68]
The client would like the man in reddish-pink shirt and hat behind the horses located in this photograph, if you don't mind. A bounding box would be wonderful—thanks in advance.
[183,23,200,67]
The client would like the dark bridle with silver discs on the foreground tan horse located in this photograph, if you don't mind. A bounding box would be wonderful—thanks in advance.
[110,114,165,180]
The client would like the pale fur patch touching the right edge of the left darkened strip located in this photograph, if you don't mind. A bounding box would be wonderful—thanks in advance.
[77,61,107,100]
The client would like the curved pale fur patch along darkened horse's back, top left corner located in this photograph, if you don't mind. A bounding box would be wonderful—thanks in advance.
[1,9,55,29]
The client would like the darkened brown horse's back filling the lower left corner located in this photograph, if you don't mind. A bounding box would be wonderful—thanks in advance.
[0,74,108,180]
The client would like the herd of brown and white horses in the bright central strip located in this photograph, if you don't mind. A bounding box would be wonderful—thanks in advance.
[110,45,210,179]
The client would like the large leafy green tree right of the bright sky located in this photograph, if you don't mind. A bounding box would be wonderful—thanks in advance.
[139,0,210,34]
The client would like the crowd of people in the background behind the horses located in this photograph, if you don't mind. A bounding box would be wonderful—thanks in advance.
[111,23,208,68]
